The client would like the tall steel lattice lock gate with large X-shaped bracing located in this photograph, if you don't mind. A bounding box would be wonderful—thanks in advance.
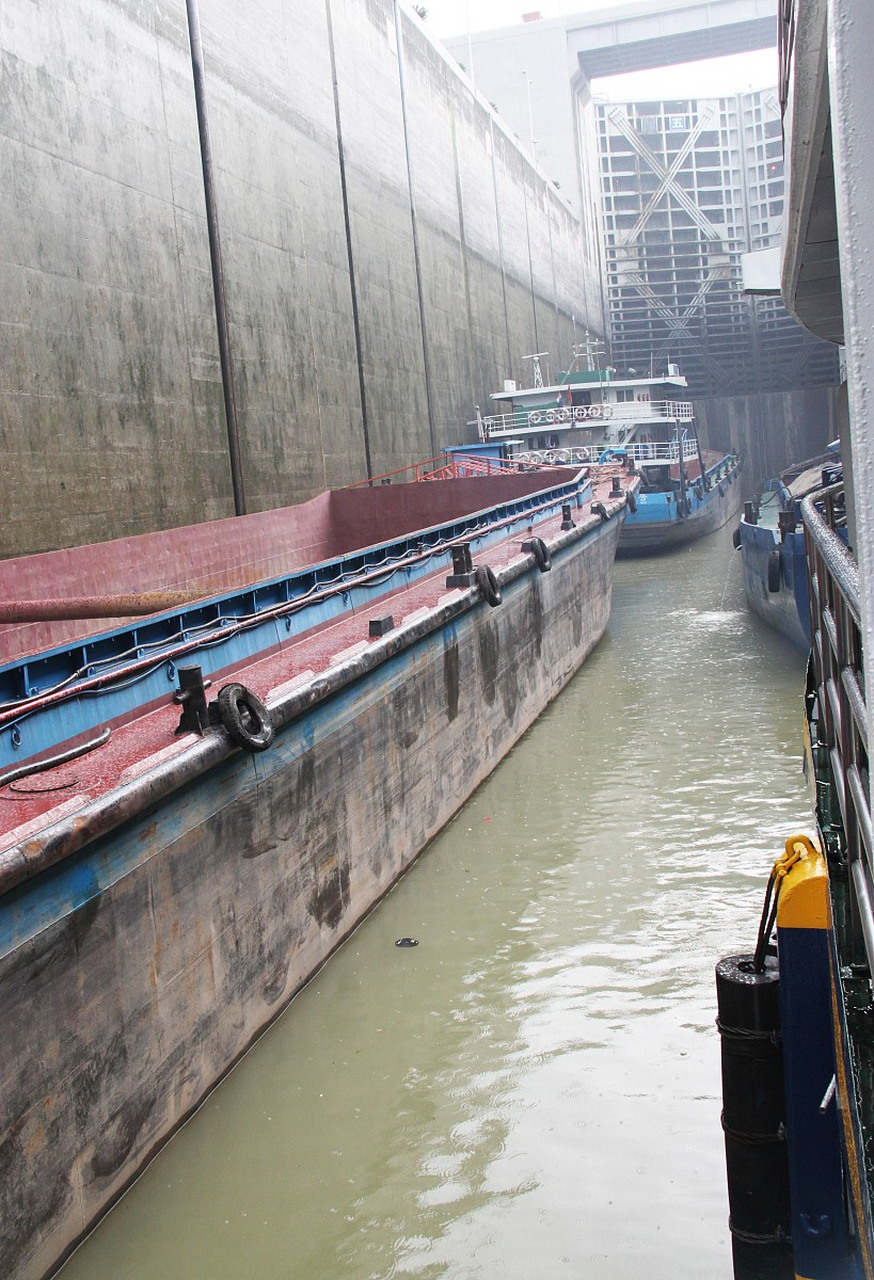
[598,90,838,396]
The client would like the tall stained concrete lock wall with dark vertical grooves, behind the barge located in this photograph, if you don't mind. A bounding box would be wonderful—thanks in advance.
[0,0,603,556]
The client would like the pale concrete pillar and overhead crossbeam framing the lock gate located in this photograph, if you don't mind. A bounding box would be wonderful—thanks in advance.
[444,0,777,211]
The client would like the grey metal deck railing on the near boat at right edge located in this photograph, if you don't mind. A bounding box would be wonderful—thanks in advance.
[801,484,874,973]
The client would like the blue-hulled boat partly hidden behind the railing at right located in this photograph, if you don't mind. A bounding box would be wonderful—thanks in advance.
[735,445,846,652]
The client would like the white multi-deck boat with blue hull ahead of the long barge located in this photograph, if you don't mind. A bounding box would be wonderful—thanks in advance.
[468,348,741,556]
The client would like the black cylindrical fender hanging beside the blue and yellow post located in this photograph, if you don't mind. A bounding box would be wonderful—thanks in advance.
[717,955,795,1280]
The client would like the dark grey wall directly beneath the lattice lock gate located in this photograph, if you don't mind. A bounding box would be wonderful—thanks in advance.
[695,387,839,497]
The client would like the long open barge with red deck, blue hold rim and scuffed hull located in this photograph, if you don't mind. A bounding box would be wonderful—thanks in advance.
[0,467,636,1280]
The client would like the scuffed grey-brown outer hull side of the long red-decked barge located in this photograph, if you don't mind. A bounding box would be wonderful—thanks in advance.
[0,521,618,1280]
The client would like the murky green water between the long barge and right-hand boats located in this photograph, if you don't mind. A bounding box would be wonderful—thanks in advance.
[63,530,809,1280]
